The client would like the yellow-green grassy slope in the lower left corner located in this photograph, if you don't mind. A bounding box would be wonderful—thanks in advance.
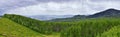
[0,18,42,37]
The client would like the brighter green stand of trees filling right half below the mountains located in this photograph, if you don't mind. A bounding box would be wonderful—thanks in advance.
[61,18,120,37]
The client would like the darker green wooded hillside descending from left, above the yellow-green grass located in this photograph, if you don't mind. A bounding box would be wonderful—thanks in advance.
[3,14,74,35]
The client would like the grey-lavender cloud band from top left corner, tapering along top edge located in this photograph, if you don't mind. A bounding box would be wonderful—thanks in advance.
[0,0,81,15]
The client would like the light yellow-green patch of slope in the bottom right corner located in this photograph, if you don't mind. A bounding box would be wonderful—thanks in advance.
[97,25,120,37]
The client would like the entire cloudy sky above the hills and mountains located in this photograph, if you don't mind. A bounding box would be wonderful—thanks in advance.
[0,0,120,15]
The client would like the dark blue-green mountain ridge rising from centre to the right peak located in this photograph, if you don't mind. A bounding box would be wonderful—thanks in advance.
[50,9,120,21]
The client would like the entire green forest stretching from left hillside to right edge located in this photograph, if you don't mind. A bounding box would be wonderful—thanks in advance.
[2,14,120,37]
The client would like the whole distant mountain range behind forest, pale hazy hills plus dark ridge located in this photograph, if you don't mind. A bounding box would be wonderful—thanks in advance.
[0,9,120,21]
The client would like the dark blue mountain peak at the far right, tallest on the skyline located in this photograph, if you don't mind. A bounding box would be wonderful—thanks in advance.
[88,9,120,18]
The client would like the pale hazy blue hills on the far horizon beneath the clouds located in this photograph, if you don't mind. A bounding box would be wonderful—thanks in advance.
[29,15,73,20]
